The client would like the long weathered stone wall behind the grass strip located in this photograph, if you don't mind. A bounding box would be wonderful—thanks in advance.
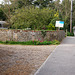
[0,29,65,41]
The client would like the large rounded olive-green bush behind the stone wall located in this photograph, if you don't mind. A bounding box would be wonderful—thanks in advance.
[11,7,55,30]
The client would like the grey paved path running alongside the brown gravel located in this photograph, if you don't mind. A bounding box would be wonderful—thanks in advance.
[34,37,75,75]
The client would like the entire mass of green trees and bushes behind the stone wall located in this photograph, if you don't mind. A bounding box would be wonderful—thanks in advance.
[0,0,75,31]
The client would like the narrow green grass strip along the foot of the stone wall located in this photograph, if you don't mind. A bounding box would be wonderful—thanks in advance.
[0,40,60,45]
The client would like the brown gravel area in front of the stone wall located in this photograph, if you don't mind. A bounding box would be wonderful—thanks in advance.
[0,45,56,75]
